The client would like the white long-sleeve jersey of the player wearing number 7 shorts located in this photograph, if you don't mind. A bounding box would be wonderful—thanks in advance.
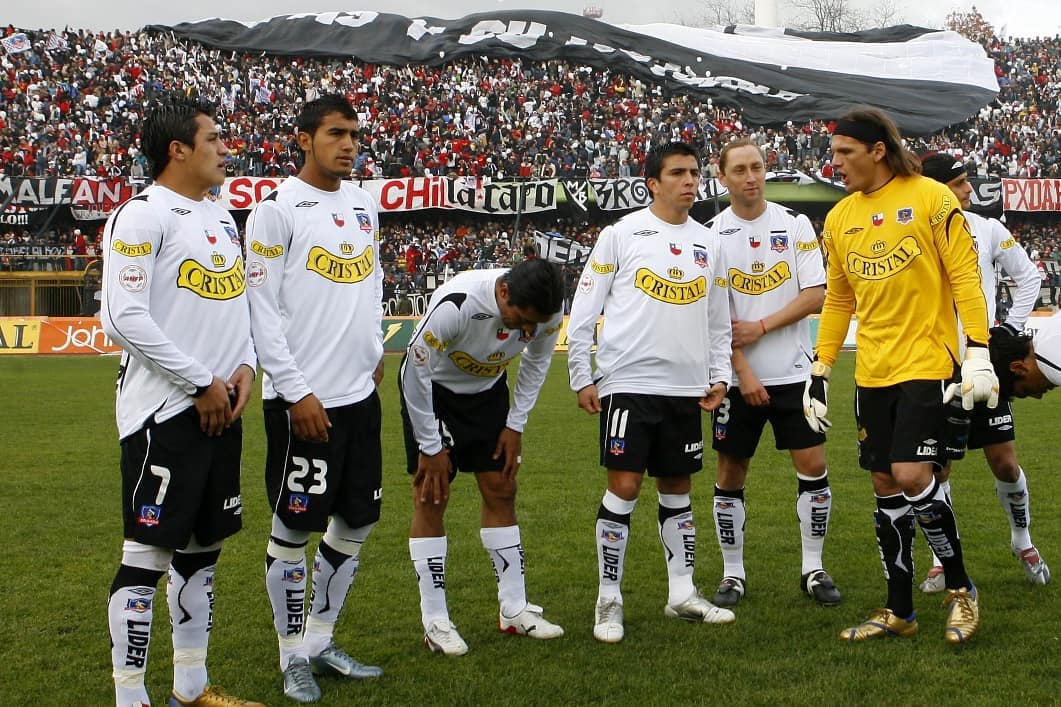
[100,184,255,438]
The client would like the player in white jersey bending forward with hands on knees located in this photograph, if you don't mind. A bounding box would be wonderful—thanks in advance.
[398,259,563,656]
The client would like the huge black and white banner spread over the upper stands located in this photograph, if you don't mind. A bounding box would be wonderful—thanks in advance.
[153,10,998,134]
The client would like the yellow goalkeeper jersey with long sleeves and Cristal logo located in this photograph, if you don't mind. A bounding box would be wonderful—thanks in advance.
[817,175,988,387]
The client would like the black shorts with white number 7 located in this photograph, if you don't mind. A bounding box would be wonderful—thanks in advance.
[121,407,243,550]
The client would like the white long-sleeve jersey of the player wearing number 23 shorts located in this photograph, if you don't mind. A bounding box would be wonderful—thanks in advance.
[246,177,383,408]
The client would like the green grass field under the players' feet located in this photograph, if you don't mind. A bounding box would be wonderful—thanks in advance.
[0,355,1061,705]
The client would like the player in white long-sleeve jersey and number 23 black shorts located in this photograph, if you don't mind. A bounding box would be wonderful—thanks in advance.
[246,96,383,703]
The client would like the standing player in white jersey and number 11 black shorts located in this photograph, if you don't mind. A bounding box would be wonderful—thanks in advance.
[568,142,734,643]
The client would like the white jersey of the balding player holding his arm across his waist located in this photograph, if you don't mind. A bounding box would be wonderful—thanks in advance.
[707,202,825,385]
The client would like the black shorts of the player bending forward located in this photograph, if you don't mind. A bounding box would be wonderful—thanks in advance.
[399,373,508,473]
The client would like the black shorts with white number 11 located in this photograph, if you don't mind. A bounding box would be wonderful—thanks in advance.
[601,393,703,477]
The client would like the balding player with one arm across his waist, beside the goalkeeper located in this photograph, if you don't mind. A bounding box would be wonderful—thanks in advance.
[707,139,840,606]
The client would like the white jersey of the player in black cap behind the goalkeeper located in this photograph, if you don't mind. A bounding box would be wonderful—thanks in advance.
[959,211,1042,329]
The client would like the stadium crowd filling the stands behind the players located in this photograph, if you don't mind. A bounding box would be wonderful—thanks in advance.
[0,27,1061,290]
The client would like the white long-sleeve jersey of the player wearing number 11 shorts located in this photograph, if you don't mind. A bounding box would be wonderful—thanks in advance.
[568,208,732,397]
